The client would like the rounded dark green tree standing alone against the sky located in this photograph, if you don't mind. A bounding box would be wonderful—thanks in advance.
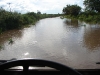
[63,5,81,16]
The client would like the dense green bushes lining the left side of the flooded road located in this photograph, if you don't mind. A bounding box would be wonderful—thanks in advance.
[0,8,59,34]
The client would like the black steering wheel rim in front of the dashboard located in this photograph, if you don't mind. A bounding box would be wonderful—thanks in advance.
[0,59,81,75]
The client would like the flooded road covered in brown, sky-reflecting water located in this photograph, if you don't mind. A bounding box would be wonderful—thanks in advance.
[0,17,100,69]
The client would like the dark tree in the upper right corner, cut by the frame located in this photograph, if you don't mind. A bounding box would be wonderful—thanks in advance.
[83,0,100,12]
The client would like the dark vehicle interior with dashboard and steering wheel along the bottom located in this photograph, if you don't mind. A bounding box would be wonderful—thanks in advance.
[0,59,100,75]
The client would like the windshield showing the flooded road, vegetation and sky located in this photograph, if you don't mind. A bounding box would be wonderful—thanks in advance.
[0,0,100,69]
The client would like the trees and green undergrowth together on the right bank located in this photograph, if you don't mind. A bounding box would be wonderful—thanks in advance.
[62,0,100,24]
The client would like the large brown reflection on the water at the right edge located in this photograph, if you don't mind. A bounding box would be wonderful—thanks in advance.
[83,25,100,50]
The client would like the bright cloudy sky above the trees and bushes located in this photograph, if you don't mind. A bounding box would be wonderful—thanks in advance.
[0,0,84,14]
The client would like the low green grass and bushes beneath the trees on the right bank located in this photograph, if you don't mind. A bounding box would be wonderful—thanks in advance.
[65,12,100,24]
